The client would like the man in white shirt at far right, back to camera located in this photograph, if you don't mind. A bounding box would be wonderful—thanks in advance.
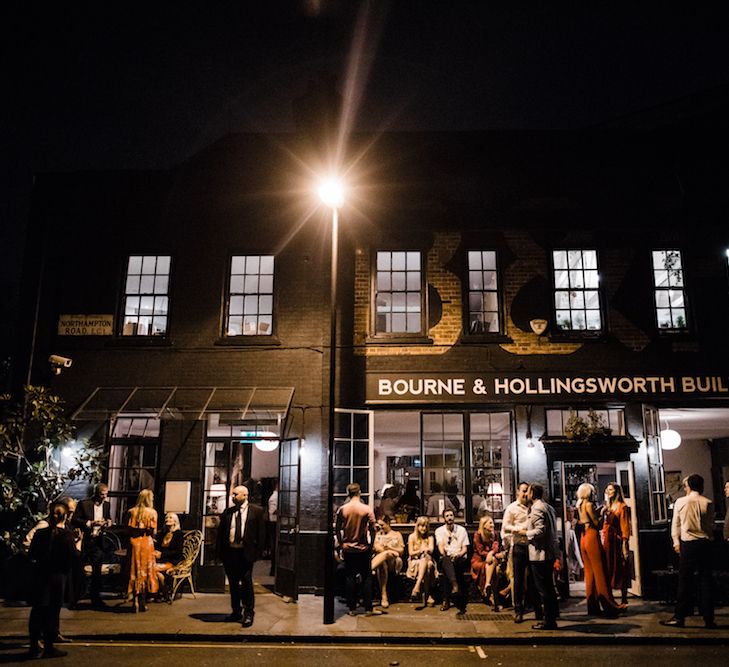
[661,474,716,628]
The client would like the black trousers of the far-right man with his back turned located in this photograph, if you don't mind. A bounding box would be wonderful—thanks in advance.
[673,540,714,623]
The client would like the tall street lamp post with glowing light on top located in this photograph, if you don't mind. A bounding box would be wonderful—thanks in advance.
[319,178,344,624]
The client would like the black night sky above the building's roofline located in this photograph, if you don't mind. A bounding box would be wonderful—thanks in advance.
[0,0,729,350]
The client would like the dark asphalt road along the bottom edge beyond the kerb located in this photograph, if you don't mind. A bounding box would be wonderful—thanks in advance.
[0,642,729,667]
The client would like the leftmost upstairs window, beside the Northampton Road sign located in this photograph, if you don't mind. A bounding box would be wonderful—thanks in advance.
[122,255,171,336]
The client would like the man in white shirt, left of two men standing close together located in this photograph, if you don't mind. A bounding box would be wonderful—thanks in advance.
[501,482,541,623]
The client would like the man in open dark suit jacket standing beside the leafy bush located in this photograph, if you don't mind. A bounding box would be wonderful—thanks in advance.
[72,484,111,607]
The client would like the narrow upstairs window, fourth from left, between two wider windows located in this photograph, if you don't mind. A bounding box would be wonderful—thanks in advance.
[468,250,501,334]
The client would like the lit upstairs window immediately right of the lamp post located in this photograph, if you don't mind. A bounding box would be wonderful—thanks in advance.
[375,251,423,334]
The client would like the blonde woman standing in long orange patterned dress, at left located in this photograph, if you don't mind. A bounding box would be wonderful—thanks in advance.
[127,489,159,612]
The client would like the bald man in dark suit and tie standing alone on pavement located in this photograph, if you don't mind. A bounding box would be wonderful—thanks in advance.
[217,486,266,628]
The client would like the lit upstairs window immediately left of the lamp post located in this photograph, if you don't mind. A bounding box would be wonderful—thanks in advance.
[225,255,274,336]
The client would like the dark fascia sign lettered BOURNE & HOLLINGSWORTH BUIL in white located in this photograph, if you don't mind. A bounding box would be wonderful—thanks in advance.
[367,373,729,403]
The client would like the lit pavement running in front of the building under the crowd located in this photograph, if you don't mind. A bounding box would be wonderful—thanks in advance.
[0,583,729,644]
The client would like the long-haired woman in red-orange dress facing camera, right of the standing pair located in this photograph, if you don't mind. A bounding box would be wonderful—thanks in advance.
[600,482,631,604]
